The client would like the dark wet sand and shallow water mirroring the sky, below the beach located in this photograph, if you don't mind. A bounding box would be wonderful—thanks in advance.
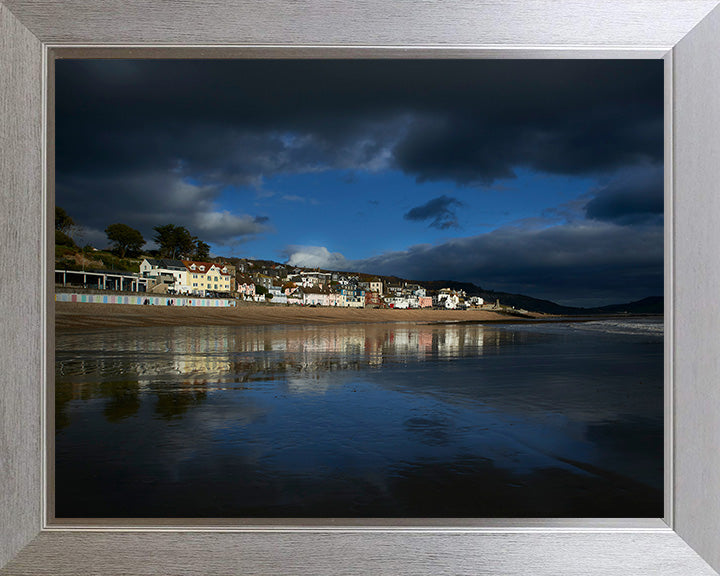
[55,318,663,518]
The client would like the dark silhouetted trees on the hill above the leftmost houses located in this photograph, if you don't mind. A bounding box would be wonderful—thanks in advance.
[55,206,210,260]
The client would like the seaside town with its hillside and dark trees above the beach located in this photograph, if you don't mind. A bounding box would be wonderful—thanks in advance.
[55,207,501,310]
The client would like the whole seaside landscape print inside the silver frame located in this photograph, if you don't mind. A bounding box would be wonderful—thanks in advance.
[48,57,664,526]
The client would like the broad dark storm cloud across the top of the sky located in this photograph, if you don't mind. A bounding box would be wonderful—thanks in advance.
[56,60,663,191]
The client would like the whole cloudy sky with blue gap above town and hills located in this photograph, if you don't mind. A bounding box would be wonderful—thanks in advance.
[56,60,663,306]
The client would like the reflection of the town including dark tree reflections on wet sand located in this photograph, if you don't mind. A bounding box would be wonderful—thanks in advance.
[55,324,527,428]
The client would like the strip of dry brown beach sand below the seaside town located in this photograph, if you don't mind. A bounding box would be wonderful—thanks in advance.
[55,302,543,331]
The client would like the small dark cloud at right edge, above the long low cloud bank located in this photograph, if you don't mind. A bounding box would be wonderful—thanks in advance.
[585,167,664,225]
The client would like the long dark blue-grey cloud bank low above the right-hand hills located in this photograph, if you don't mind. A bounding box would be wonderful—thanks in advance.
[289,221,663,307]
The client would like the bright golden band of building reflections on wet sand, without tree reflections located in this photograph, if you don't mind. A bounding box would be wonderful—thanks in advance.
[57,325,516,384]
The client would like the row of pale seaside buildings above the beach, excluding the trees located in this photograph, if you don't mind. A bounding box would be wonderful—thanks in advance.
[55,257,498,310]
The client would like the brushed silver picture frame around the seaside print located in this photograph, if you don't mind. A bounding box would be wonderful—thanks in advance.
[0,0,720,576]
